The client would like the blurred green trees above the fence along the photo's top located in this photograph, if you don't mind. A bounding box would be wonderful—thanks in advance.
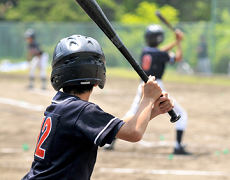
[0,0,211,22]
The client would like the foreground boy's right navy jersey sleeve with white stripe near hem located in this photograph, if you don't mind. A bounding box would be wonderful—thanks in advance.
[75,103,124,147]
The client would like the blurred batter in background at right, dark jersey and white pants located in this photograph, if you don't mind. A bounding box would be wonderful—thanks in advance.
[105,24,191,155]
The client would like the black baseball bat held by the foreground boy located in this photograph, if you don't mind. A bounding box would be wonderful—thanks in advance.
[76,0,180,123]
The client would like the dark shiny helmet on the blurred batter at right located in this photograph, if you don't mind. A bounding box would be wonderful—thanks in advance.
[145,24,164,47]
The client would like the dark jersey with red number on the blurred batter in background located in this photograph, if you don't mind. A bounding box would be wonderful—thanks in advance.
[141,46,175,79]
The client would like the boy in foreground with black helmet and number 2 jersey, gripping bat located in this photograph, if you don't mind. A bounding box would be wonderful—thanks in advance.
[22,35,173,180]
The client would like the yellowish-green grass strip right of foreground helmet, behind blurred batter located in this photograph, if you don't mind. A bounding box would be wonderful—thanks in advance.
[107,68,230,86]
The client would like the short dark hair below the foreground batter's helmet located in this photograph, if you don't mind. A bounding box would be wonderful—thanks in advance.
[63,84,94,94]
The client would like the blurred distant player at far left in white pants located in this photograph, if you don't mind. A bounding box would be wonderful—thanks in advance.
[25,29,49,89]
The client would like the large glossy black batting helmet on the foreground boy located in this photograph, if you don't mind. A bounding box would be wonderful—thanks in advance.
[51,35,106,91]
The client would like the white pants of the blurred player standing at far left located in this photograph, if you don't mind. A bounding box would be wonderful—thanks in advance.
[29,52,49,89]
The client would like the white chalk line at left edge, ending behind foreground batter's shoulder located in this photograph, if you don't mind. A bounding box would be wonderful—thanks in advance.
[0,97,45,111]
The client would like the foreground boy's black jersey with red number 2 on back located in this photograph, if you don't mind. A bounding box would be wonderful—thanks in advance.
[22,91,124,180]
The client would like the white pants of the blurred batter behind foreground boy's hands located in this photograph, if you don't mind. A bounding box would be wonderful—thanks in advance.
[125,79,188,131]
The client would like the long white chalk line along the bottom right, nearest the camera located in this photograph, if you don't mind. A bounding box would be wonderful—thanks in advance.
[99,167,230,176]
